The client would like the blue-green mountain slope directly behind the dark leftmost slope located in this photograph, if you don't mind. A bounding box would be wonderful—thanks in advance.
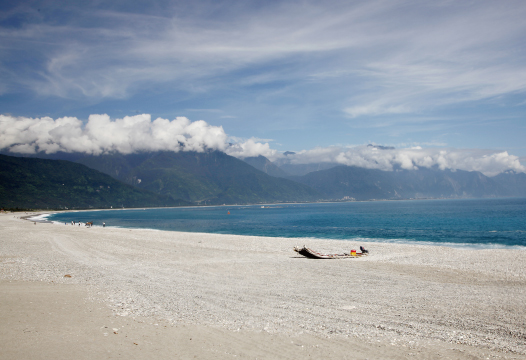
[78,151,321,204]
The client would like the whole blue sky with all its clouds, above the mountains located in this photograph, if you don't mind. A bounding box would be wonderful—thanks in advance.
[0,0,526,175]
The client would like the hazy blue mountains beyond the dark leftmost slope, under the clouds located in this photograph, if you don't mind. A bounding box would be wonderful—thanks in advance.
[4,151,526,206]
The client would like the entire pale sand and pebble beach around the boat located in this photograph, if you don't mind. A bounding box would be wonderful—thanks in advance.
[0,214,526,359]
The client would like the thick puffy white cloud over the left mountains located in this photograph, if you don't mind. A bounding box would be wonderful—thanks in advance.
[0,114,227,155]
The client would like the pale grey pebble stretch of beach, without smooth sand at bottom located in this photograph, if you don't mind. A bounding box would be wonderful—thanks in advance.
[0,214,526,355]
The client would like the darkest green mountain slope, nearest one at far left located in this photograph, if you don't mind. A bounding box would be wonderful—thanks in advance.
[0,155,182,209]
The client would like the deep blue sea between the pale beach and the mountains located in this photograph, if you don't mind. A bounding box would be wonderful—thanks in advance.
[49,198,526,247]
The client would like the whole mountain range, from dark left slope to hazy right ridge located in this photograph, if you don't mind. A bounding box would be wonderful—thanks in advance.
[0,151,526,208]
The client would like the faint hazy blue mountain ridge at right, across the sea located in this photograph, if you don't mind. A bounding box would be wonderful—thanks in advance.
[290,166,526,200]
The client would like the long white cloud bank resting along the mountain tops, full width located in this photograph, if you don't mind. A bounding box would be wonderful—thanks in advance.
[0,114,526,176]
